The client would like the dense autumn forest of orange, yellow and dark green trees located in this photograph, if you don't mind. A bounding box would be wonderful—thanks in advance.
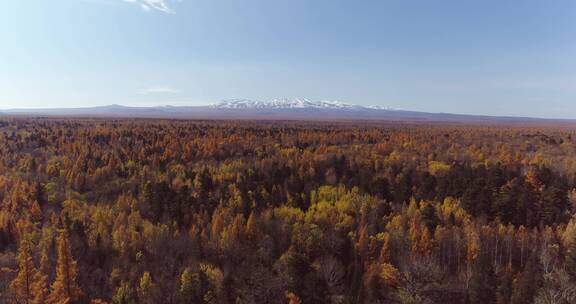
[0,118,576,304]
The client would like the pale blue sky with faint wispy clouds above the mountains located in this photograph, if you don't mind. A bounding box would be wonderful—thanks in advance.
[0,0,576,118]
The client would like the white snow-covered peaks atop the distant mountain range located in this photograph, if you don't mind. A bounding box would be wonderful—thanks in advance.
[211,98,368,110]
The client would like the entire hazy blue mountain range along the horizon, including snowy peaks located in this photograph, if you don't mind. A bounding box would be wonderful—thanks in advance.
[0,98,576,124]
